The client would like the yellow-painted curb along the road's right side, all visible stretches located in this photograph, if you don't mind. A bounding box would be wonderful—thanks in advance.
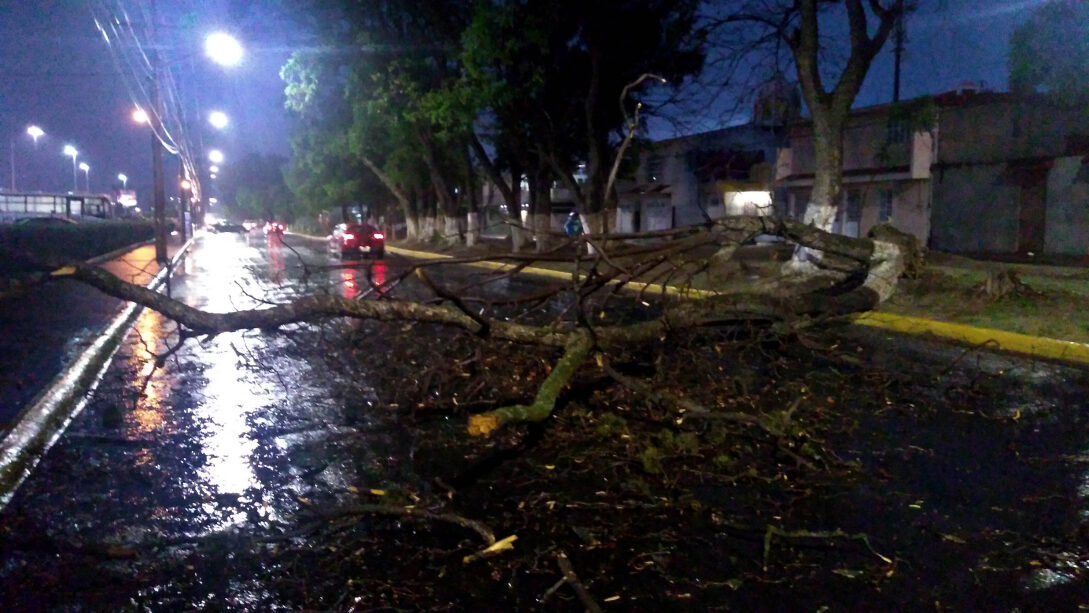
[386,246,1089,364]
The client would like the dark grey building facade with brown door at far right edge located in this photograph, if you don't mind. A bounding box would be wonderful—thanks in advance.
[930,90,1089,256]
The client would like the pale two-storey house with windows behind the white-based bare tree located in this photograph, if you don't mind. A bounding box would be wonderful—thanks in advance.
[774,101,938,243]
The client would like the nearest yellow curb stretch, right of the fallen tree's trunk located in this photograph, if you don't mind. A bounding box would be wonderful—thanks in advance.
[855,311,1089,364]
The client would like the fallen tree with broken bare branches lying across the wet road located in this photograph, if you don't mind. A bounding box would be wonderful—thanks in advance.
[8,217,917,436]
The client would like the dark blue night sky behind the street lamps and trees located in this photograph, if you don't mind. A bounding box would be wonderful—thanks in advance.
[0,0,1043,201]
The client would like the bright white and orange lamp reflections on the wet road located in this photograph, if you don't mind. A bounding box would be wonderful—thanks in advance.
[4,233,402,609]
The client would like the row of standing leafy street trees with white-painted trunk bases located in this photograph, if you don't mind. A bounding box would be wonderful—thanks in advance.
[281,0,906,250]
